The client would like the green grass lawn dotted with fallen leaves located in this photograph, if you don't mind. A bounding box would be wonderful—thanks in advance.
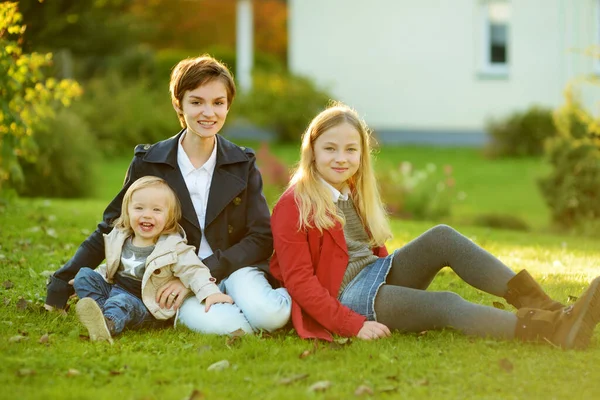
[0,143,600,400]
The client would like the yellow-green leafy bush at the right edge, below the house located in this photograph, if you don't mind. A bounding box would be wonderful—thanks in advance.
[539,90,600,233]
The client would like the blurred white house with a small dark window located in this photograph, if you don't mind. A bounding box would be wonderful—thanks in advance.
[288,0,600,141]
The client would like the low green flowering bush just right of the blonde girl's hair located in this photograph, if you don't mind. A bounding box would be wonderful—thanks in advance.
[378,161,466,220]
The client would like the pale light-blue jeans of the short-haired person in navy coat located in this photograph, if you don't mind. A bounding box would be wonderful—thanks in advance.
[178,267,292,335]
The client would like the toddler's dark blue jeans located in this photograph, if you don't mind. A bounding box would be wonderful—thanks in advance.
[73,267,156,334]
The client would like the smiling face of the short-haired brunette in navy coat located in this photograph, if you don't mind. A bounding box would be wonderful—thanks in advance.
[176,79,229,138]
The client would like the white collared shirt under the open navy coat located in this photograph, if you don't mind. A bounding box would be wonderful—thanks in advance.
[177,133,217,259]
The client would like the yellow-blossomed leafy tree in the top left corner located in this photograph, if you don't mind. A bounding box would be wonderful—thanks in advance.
[0,2,81,188]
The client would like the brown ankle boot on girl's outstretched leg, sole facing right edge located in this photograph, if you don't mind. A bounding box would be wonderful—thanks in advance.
[515,277,600,349]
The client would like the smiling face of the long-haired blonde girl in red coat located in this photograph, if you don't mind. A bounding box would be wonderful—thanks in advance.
[313,122,361,190]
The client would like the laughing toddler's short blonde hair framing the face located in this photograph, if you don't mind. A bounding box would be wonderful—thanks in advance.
[113,175,181,238]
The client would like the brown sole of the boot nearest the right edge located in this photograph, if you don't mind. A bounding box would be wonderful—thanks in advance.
[564,277,600,349]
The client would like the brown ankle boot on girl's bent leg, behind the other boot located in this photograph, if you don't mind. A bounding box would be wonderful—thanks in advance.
[504,270,564,311]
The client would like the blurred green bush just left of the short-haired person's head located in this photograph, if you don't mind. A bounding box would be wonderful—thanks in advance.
[76,74,180,155]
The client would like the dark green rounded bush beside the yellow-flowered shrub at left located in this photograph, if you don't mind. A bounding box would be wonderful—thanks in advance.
[17,109,100,198]
